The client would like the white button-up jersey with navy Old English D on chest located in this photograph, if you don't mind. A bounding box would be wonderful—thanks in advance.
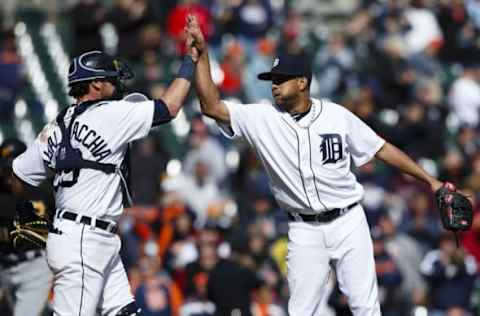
[220,99,385,214]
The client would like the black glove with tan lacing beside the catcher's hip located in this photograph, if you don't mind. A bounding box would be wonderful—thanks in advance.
[10,201,48,250]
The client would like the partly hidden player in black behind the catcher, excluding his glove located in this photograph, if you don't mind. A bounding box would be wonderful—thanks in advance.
[0,138,52,316]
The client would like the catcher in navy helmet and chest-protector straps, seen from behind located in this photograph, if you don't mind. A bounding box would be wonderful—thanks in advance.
[5,32,196,316]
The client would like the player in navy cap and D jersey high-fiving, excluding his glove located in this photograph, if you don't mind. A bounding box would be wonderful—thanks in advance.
[187,16,442,316]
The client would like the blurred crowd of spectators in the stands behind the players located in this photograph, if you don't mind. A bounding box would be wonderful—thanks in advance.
[0,0,480,316]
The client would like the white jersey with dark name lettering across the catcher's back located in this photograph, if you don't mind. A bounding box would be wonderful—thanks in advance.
[12,100,154,220]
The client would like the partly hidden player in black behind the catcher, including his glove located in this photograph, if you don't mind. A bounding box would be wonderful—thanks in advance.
[0,139,52,316]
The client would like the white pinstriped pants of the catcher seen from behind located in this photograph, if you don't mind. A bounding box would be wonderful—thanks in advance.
[47,218,134,316]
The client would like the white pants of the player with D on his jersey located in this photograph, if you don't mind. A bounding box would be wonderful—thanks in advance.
[287,205,381,316]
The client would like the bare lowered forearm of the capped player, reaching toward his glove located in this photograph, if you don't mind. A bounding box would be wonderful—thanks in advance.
[375,142,443,192]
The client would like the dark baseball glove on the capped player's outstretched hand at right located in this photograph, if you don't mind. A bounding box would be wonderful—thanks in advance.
[435,183,473,232]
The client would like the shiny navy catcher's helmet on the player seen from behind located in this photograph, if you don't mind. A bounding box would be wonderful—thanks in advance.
[68,51,133,85]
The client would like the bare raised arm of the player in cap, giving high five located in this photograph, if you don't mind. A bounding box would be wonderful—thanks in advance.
[187,15,230,123]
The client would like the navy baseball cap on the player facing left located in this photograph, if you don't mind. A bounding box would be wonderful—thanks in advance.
[258,55,312,81]
